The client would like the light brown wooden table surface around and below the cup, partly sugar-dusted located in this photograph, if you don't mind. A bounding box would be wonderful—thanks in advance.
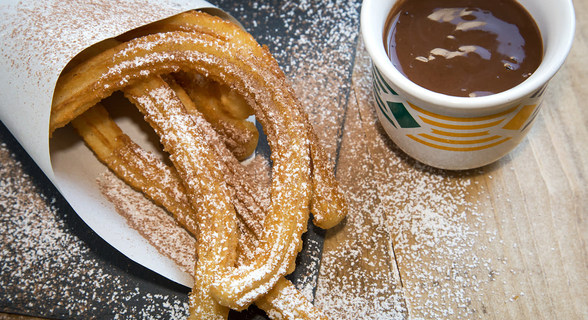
[316,1,588,319]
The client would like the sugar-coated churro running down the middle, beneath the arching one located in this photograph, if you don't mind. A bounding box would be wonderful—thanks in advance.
[123,76,238,319]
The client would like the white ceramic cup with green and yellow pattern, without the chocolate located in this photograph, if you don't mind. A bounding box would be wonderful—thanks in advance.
[361,0,575,170]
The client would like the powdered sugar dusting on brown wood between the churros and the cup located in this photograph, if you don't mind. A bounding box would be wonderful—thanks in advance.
[317,38,504,319]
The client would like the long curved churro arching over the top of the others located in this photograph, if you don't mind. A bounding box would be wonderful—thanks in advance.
[52,27,310,309]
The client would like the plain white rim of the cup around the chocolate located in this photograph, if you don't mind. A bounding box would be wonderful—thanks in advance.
[360,0,576,110]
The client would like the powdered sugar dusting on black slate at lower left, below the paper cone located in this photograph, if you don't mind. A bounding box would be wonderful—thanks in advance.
[0,143,187,319]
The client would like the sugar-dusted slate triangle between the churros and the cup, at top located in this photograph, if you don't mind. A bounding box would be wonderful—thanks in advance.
[221,0,360,162]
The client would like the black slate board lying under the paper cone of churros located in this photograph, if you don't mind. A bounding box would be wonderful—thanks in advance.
[0,0,359,319]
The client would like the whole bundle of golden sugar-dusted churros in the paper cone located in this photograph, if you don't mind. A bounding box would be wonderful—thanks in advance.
[50,12,347,319]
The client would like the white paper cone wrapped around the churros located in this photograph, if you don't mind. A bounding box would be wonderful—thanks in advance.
[0,0,241,287]
